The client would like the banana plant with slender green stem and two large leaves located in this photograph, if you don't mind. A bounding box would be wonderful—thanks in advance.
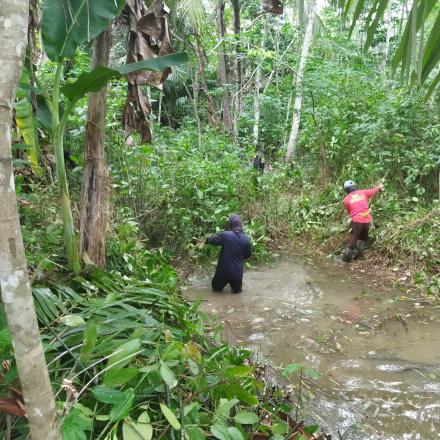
[39,0,186,273]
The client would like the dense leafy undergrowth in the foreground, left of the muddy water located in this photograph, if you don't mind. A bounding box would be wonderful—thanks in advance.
[0,270,300,440]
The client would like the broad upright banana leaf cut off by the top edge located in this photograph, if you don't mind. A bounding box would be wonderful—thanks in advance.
[41,0,124,61]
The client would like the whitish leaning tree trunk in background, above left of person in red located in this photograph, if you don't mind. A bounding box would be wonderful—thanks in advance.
[285,0,315,162]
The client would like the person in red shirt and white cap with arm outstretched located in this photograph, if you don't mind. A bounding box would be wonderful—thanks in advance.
[342,180,383,263]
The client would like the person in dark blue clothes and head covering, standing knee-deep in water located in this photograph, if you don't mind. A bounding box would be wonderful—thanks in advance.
[207,214,252,293]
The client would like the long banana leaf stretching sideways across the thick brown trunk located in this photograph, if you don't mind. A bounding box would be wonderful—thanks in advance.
[61,52,188,102]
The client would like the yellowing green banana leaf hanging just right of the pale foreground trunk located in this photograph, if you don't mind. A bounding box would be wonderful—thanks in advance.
[15,98,42,175]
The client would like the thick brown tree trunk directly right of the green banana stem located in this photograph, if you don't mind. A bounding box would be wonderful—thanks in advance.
[79,24,111,268]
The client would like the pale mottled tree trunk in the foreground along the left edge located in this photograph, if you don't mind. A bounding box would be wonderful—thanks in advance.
[0,0,60,440]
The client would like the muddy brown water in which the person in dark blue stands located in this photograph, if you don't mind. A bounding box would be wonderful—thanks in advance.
[187,257,440,440]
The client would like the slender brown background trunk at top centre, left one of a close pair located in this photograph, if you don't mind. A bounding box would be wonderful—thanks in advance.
[218,0,234,133]
